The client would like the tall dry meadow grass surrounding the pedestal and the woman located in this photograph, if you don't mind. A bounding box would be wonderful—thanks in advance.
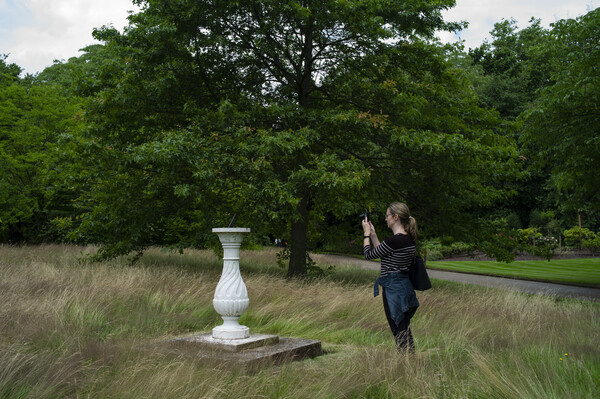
[0,245,600,398]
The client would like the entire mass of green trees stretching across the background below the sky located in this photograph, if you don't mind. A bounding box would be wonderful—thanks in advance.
[10,0,600,268]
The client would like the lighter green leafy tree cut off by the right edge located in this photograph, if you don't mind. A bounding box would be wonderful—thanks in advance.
[523,9,600,211]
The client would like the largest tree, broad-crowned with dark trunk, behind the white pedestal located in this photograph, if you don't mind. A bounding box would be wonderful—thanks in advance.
[69,0,518,275]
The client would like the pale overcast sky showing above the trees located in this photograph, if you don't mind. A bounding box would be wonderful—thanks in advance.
[0,0,600,74]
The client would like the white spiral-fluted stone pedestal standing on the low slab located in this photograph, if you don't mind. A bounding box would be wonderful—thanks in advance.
[212,227,250,340]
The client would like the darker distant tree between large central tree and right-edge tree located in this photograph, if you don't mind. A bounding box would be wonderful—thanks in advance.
[469,18,584,231]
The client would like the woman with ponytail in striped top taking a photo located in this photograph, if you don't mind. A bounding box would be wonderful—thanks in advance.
[362,202,419,352]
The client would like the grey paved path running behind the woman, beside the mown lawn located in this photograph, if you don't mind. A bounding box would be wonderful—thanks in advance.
[311,254,600,302]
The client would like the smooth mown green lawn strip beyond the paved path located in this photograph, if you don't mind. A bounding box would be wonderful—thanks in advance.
[427,258,600,286]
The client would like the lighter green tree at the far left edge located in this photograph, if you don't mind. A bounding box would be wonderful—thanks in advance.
[0,57,78,242]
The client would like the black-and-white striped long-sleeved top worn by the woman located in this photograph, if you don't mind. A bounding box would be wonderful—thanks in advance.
[363,234,416,276]
